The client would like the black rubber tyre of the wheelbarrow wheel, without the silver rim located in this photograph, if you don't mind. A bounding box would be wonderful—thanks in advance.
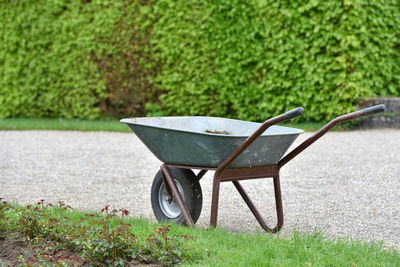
[151,168,203,225]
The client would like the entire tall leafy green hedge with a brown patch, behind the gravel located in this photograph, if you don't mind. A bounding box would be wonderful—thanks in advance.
[0,0,400,121]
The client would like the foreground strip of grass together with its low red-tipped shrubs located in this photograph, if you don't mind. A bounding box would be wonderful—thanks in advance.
[0,201,400,266]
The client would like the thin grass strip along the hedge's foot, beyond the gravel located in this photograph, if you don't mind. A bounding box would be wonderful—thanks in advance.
[0,118,349,132]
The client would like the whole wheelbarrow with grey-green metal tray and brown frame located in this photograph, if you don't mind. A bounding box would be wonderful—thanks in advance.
[121,104,385,232]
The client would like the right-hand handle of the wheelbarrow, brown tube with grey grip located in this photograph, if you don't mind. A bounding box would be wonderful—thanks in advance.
[278,104,386,168]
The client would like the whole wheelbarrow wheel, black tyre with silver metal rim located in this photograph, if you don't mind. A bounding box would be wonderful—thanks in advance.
[151,168,203,224]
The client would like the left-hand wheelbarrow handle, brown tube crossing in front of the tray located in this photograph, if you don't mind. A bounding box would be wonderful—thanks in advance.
[215,107,304,176]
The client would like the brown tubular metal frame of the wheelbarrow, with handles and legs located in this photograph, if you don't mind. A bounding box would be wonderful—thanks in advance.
[161,105,385,233]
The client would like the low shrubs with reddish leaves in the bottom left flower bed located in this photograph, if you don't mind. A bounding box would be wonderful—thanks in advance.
[0,200,192,266]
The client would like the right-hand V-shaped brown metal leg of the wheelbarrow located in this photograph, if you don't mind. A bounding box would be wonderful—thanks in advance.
[232,175,283,233]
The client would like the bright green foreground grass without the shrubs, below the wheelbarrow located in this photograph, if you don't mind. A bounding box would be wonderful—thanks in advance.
[1,202,400,266]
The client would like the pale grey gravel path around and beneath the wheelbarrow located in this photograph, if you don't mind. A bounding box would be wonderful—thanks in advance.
[0,130,400,250]
